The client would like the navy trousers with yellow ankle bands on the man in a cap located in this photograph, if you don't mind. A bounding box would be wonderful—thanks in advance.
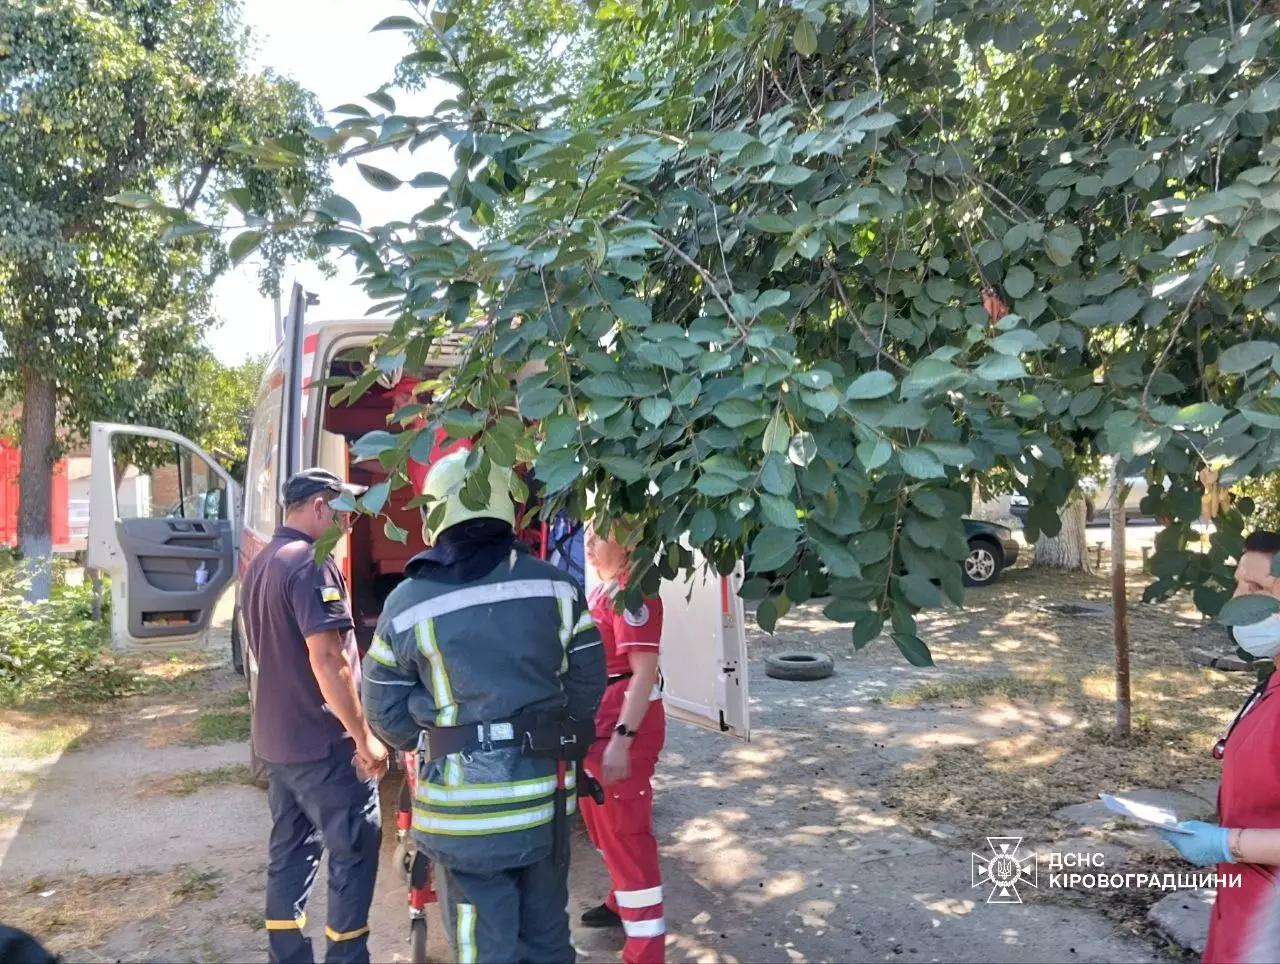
[266,740,383,964]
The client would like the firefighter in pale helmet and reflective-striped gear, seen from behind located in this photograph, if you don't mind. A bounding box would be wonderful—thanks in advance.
[364,451,604,964]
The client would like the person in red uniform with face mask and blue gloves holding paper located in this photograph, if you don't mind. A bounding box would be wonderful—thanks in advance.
[1158,531,1280,964]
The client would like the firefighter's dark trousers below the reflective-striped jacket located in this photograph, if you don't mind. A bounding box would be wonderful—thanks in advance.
[436,837,575,964]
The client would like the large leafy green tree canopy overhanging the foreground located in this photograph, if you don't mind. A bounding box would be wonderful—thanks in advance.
[167,0,1280,664]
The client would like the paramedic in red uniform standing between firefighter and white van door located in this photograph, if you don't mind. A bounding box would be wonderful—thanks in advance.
[581,525,667,964]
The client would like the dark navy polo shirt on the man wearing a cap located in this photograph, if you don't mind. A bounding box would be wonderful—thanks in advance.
[239,526,360,763]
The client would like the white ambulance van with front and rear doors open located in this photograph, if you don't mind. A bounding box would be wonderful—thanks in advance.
[87,285,748,740]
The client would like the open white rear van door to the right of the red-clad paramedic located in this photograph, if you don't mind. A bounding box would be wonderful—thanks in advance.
[586,553,750,740]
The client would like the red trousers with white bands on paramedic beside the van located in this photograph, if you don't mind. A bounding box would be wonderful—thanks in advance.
[579,681,667,964]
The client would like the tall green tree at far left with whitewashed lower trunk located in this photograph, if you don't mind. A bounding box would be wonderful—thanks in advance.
[0,0,328,595]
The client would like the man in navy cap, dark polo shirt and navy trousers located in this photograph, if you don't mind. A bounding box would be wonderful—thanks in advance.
[239,469,387,963]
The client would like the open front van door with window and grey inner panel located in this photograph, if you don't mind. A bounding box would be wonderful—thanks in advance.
[86,422,241,649]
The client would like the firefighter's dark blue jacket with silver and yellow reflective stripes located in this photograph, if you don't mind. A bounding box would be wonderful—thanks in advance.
[364,535,605,873]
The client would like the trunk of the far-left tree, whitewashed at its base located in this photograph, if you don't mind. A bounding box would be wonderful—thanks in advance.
[18,369,58,602]
